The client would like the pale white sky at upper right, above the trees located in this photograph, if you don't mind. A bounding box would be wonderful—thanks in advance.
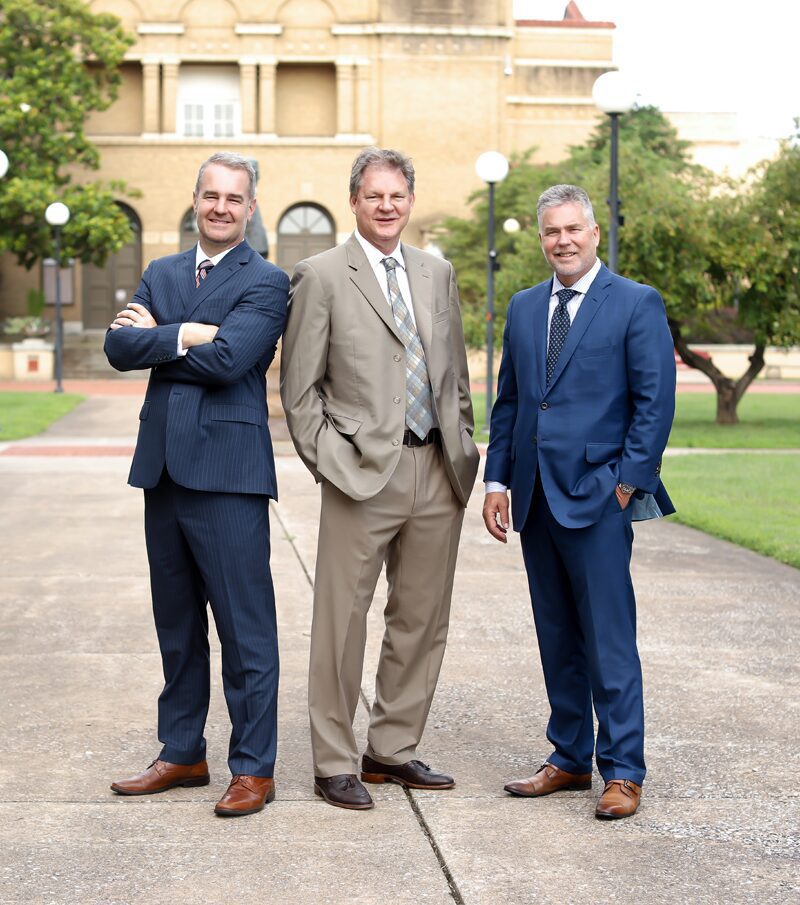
[514,0,800,138]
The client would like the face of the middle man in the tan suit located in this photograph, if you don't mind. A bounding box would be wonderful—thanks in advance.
[350,166,414,254]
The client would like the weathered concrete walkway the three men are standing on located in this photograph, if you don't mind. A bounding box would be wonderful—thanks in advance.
[0,395,800,905]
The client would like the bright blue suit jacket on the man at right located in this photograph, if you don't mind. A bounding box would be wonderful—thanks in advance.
[484,266,675,531]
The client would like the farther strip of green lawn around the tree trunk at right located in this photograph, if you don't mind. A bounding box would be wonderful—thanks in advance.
[472,392,800,449]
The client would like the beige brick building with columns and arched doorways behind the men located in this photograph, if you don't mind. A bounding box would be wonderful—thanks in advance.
[0,0,614,331]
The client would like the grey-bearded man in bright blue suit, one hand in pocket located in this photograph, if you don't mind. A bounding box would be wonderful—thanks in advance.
[483,185,675,819]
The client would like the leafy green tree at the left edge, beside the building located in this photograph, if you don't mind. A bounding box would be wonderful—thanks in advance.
[0,0,133,268]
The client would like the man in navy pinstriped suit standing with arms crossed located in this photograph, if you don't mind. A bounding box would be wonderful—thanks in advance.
[105,154,289,816]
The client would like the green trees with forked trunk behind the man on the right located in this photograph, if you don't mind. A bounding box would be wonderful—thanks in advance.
[440,107,800,424]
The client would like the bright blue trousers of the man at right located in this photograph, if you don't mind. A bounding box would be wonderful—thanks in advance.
[521,479,645,785]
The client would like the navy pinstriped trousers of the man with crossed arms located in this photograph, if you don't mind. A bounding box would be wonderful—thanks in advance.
[144,470,278,776]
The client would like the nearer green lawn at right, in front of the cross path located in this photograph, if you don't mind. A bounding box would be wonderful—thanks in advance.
[663,453,800,568]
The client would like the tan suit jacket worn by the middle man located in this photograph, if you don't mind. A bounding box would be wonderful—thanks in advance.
[281,236,479,506]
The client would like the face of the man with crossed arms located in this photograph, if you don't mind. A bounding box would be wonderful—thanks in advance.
[193,163,256,257]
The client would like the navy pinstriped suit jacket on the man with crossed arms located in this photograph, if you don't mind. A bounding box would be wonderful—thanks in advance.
[105,242,289,499]
